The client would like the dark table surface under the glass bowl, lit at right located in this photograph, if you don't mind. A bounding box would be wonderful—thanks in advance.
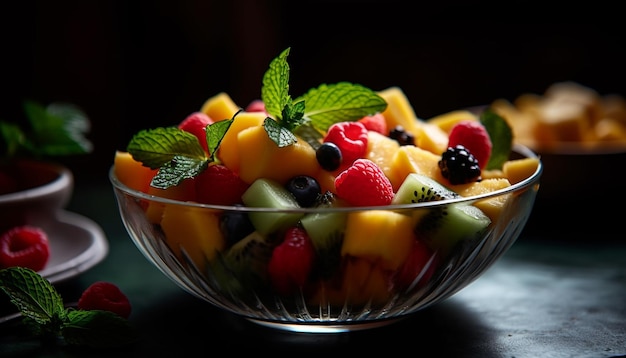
[0,182,626,358]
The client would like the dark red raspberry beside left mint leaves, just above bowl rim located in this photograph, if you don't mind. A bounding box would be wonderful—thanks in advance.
[194,164,249,205]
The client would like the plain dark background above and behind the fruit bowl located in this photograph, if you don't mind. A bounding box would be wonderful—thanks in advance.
[0,0,626,185]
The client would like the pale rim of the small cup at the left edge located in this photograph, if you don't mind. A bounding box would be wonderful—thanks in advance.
[0,160,73,205]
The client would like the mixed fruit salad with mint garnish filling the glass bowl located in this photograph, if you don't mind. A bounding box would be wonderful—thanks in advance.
[112,49,540,304]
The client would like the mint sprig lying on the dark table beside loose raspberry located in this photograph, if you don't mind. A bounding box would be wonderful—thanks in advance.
[0,267,137,348]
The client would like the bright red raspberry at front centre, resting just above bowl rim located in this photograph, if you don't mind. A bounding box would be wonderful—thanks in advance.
[335,159,393,206]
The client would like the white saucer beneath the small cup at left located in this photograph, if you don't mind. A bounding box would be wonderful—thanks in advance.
[39,211,109,284]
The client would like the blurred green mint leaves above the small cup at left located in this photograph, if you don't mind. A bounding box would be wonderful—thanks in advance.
[0,101,93,162]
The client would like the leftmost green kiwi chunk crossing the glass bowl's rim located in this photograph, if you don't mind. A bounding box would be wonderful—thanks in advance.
[241,178,304,235]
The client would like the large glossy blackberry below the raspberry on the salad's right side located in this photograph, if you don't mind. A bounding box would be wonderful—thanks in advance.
[439,144,481,185]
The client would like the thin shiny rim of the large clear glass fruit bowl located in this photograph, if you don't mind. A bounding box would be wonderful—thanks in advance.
[109,143,543,213]
